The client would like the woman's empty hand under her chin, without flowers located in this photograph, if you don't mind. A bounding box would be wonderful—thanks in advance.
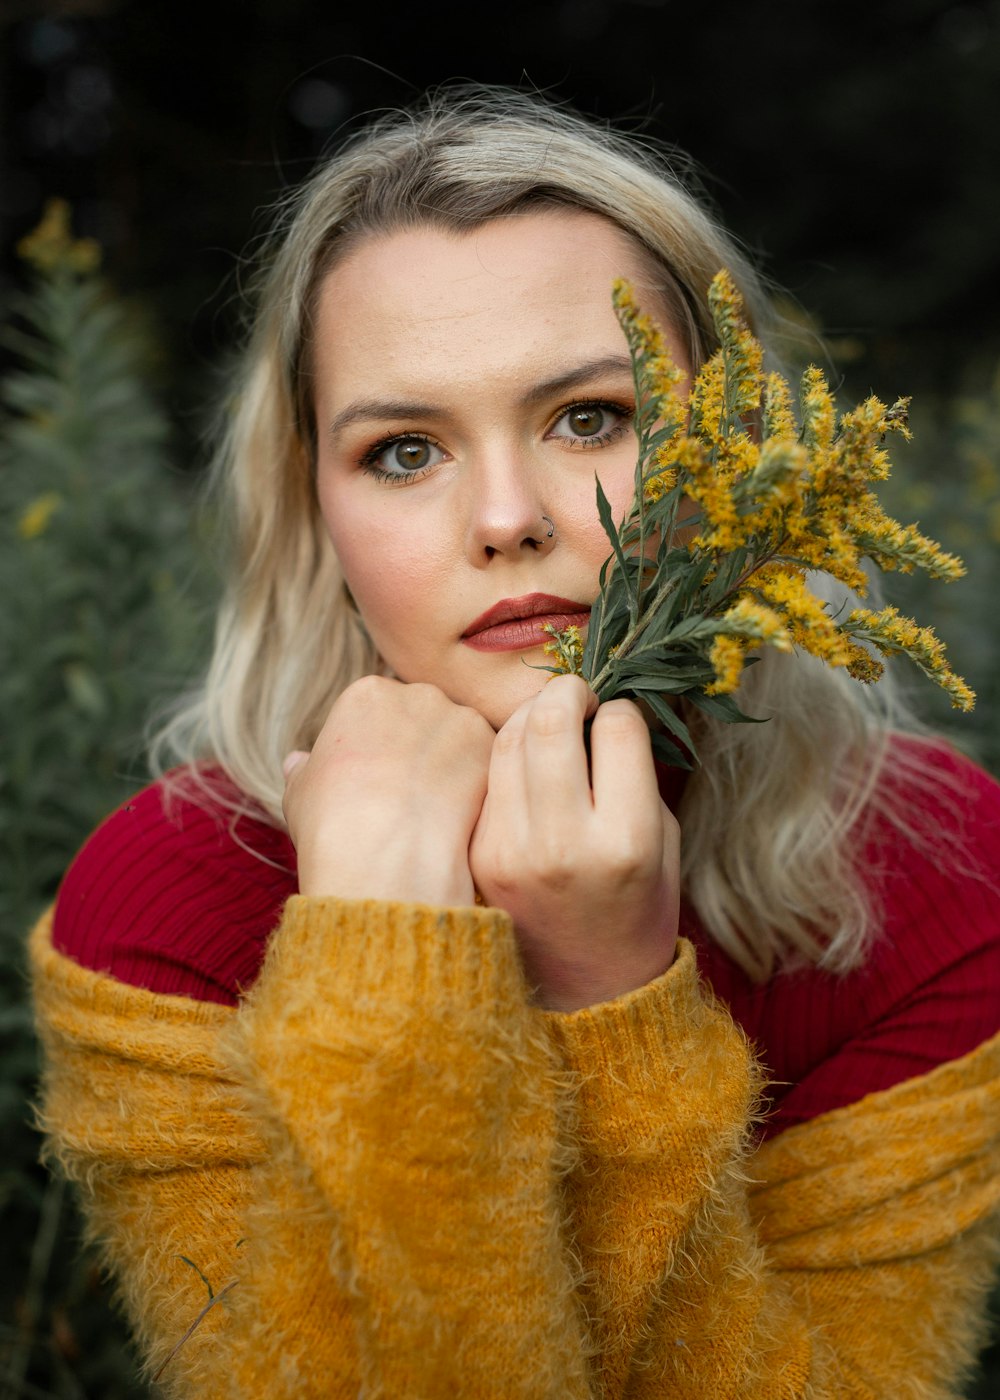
[283,676,494,904]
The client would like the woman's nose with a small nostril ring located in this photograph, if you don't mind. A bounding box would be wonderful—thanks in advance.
[468,448,556,567]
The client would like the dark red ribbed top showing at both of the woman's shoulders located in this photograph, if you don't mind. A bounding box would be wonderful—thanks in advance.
[53,741,1000,1133]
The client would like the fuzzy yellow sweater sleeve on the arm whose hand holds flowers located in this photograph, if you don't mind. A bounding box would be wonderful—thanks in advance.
[546,941,1000,1400]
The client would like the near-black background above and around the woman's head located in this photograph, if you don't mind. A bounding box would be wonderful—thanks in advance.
[0,0,1000,445]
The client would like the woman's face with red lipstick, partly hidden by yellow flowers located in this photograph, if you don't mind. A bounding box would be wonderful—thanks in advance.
[314,210,686,728]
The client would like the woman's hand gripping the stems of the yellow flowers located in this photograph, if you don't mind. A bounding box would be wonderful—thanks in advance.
[469,676,681,1011]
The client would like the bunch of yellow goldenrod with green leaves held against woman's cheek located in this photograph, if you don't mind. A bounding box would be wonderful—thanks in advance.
[545,270,975,767]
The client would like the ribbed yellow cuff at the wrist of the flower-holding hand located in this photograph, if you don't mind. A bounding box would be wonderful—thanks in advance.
[543,938,706,1075]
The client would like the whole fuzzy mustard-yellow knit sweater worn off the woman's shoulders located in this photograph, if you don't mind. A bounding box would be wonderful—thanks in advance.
[32,896,1000,1400]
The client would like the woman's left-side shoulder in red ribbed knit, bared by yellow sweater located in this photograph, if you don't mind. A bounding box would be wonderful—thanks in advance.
[52,770,296,1004]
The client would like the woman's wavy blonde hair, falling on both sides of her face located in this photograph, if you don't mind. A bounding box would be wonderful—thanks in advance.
[153,88,935,979]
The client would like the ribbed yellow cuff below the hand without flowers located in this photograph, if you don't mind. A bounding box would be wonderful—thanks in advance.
[254,895,527,1009]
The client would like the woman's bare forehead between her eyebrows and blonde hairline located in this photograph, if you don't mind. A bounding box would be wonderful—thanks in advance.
[310,210,662,372]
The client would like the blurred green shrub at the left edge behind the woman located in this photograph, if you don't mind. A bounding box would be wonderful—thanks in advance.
[0,204,206,1400]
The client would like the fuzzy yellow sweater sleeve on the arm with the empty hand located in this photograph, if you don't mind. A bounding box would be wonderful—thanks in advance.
[32,897,590,1400]
